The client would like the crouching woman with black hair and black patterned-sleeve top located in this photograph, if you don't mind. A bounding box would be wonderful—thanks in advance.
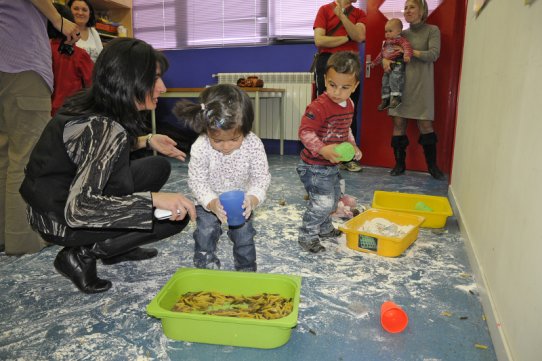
[20,38,196,293]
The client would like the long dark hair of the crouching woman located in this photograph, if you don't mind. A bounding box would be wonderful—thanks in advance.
[60,38,168,141]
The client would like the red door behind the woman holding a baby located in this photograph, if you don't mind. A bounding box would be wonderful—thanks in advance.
[360,0,467,174]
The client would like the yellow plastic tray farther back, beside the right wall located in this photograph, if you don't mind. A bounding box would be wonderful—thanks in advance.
[372,191,453,228]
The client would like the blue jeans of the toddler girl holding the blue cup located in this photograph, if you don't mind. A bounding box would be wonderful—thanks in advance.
[194,206,256,272]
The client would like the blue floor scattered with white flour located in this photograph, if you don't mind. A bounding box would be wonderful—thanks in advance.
[0,155,502,361]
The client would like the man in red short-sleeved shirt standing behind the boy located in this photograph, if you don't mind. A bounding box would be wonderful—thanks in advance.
[313,0,366,172]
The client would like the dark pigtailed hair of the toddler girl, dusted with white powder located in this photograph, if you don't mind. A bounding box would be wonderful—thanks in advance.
[173,84,254,135]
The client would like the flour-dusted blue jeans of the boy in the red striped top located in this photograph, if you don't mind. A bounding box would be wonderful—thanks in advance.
[297,161,341,245]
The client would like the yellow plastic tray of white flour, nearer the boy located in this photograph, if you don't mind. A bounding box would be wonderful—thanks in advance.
[339,208,425,257]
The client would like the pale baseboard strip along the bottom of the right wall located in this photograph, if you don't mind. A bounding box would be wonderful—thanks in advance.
[448,185,514,361]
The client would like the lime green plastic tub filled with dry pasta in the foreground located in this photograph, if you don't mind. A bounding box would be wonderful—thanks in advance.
[147,268,301,349]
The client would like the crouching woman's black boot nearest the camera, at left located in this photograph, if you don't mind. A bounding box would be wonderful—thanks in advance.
[54,246,112,293]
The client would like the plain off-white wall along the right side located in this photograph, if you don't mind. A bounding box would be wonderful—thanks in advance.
[450,0,542,361]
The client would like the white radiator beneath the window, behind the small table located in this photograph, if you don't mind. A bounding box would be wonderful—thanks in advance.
[214,73,313,140]
